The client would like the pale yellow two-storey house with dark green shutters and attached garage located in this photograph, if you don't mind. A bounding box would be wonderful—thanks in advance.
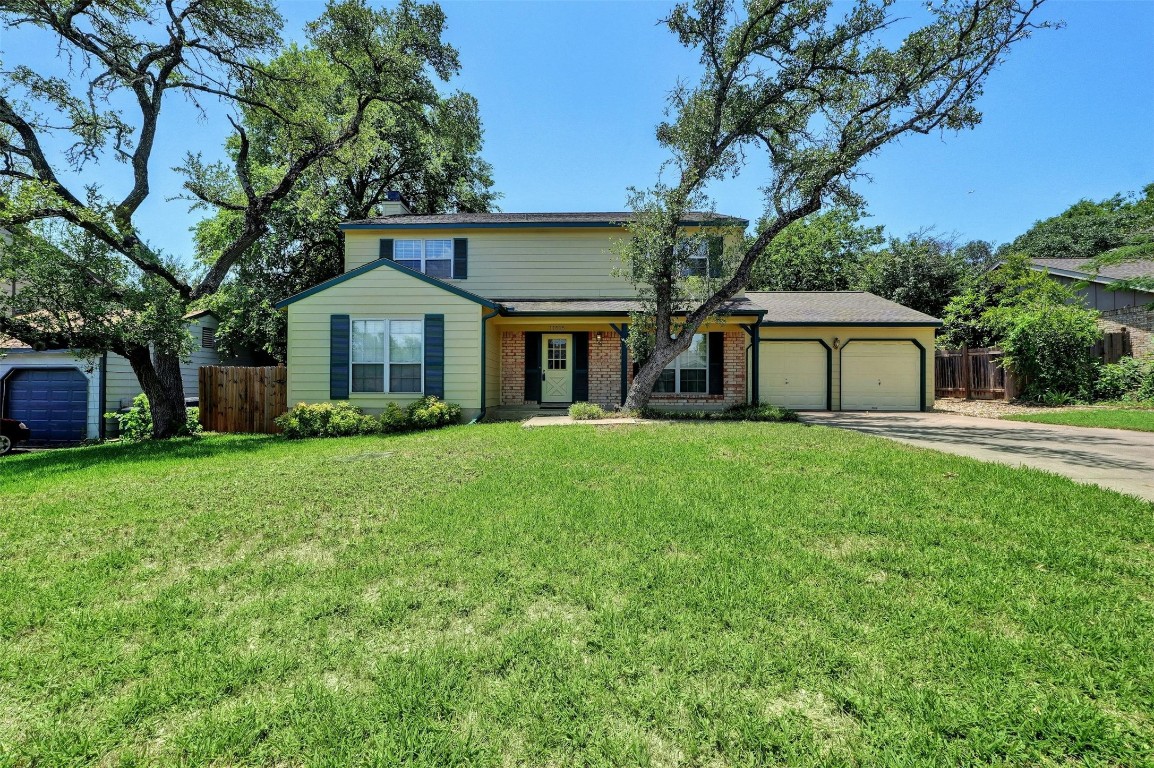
[278,194,941,419]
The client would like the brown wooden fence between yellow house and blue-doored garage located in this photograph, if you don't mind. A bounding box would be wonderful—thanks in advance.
[200,366,289,434]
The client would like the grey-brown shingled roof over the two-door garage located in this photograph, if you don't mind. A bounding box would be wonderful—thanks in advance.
[745,291,942,326]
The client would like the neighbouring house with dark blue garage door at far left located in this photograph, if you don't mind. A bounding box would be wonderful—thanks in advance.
[0,310,248,445]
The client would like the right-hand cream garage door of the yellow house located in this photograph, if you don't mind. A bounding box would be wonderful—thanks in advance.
[841,341,922,411]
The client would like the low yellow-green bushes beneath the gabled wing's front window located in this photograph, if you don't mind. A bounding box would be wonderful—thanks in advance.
[276,397,460,439]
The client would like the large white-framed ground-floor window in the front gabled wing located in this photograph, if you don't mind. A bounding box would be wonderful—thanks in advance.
[351,319,425,394]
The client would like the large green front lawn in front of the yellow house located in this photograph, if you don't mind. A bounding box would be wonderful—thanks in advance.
[0,423,1154,767]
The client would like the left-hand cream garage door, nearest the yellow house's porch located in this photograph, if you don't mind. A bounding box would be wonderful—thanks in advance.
[758,341,830,411]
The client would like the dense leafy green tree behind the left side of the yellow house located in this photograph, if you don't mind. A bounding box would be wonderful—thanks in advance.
[196,50,499,361]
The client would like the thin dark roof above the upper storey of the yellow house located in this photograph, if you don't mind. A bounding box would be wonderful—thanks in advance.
[340,211,749,229]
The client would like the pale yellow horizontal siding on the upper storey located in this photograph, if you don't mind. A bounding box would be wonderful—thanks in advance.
[345,227,747,299]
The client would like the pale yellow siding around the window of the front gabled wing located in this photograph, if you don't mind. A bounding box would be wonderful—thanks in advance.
[289,266,484,417]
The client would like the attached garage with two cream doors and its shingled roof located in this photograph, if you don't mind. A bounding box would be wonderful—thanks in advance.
[747,291,942,411]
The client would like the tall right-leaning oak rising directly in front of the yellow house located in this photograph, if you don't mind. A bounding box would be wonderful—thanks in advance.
[619,0,1044,408]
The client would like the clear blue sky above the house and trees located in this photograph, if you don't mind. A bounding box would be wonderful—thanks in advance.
[0,0,1154,256]
